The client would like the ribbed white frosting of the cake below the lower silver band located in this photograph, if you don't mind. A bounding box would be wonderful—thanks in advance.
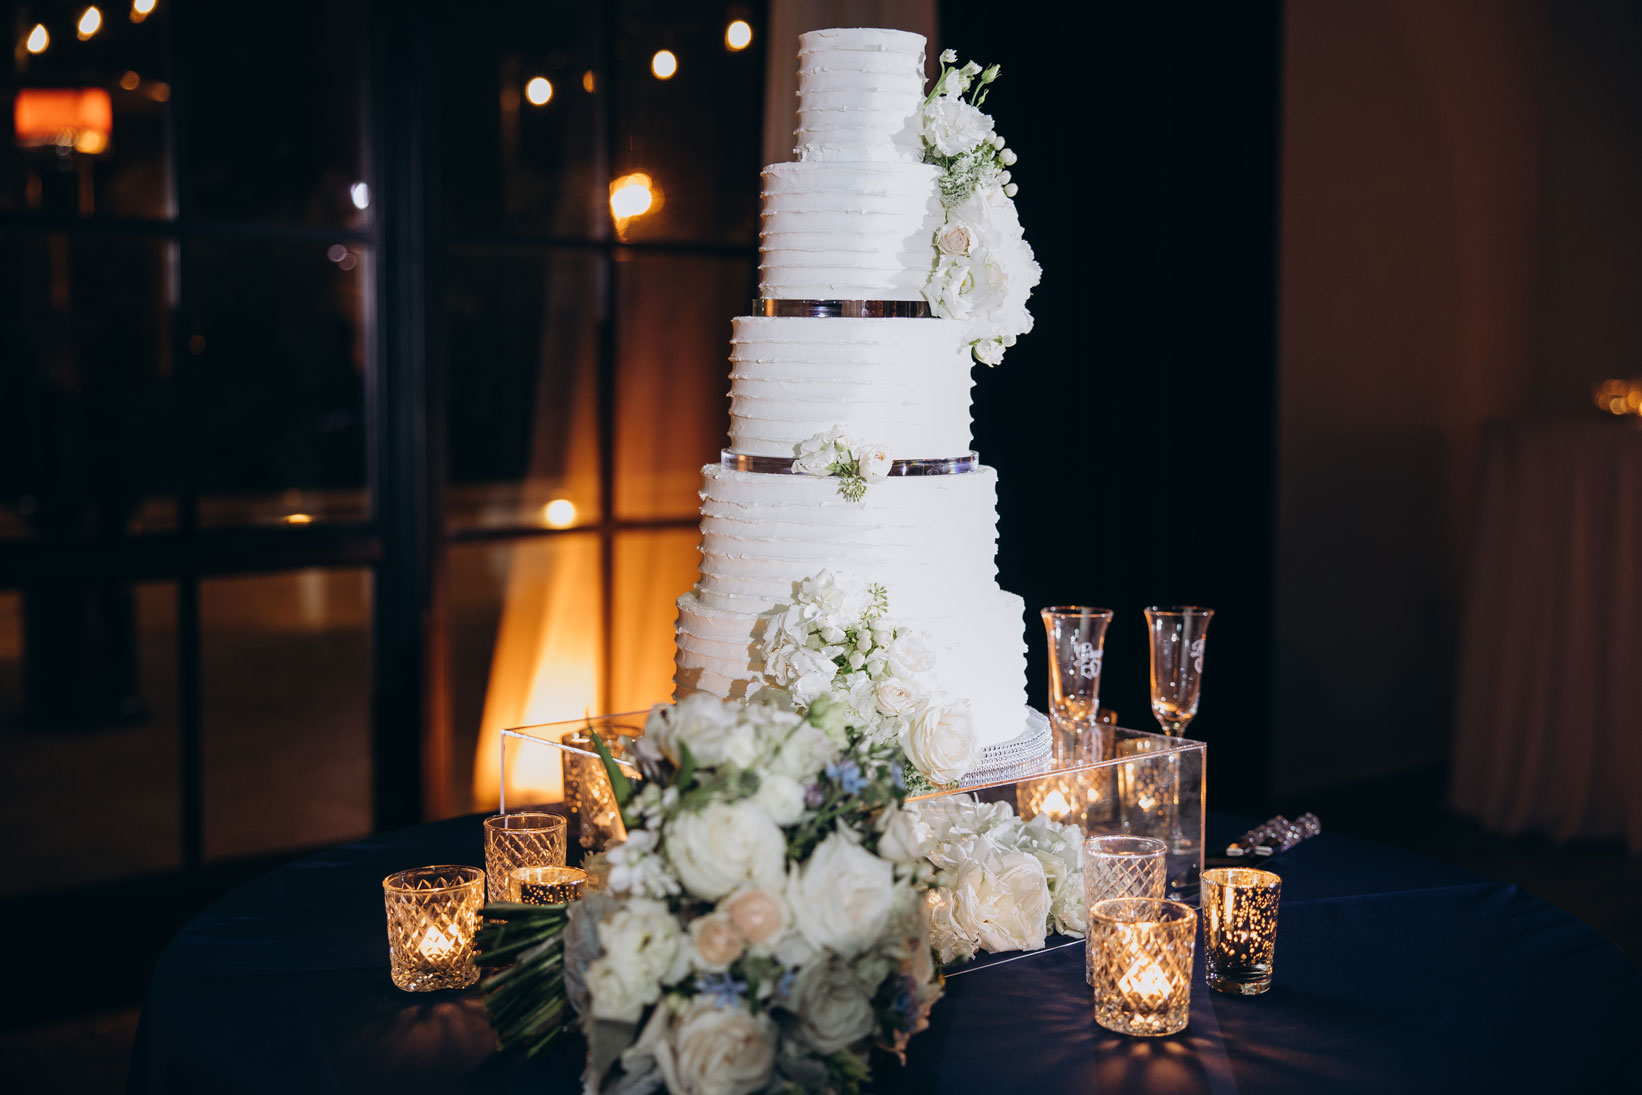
[673,462,1026,745]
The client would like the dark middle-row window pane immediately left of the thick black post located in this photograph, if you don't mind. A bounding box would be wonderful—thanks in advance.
[189,240,369,525]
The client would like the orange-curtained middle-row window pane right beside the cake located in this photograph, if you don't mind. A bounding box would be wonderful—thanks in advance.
[616,254,757,519]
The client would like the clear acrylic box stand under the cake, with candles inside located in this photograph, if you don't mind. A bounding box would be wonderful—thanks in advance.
[501,711,1205,903]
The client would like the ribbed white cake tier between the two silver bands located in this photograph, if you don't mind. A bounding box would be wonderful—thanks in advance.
[729,315,974,460]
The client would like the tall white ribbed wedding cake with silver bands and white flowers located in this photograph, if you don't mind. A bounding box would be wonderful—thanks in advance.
[675,30,1036,781]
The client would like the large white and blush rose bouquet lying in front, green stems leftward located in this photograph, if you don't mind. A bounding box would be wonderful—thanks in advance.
[478,699,941,1095]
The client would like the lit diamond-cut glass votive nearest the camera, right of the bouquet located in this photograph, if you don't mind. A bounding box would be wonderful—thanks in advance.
[1089,898,1197,1036]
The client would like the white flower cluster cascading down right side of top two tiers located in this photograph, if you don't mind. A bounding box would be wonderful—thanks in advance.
[920,49,1043,364]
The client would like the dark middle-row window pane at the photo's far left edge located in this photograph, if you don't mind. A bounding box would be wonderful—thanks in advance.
[0,235,177,538]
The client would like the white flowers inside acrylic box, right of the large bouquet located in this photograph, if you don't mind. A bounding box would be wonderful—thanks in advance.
[916,795,1089,962]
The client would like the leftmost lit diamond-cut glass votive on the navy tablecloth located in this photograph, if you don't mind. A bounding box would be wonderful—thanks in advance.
[383,865,484,992]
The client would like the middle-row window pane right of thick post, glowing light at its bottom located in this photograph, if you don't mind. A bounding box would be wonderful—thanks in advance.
[445,251,599,529]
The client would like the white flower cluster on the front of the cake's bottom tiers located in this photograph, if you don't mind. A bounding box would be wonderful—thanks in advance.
[760,570,980,786]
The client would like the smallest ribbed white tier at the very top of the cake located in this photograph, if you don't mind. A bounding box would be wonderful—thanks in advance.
[793,28,924,163]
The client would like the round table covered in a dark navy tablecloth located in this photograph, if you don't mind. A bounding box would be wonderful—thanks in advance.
[130,814,1642,1095]
